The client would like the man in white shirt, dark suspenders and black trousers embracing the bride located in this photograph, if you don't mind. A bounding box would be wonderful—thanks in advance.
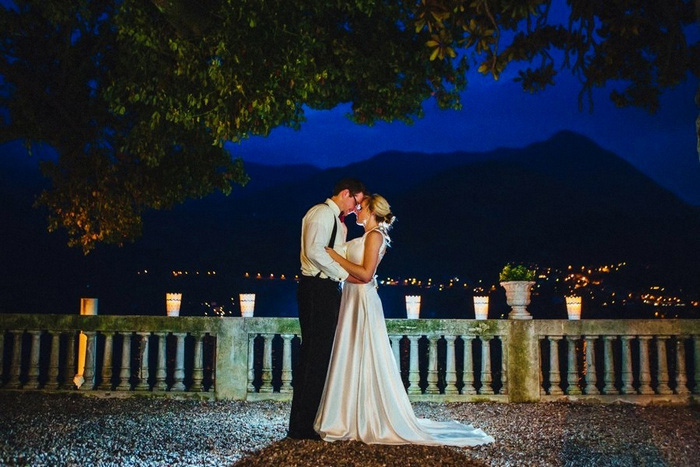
[288,178,365,439]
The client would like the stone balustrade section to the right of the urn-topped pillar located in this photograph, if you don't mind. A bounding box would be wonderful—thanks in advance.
[536,320,700,400]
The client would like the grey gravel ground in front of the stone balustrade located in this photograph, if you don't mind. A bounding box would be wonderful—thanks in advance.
[0,391,700,466]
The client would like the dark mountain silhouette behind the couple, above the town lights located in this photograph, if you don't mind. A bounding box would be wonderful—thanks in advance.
[0,132,700,313]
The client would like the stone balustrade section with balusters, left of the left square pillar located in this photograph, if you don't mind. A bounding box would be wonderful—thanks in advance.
[0,315,216,397]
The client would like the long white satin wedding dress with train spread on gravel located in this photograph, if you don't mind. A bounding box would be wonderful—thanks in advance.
[314,231,494,446]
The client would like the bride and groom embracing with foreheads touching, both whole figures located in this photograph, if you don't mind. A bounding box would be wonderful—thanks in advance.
[288,178,493,446]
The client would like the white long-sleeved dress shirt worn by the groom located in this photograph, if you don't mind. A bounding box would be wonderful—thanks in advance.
[300,198,348,282]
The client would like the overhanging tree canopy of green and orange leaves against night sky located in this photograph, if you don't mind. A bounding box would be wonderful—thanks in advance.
[0,0,700,253]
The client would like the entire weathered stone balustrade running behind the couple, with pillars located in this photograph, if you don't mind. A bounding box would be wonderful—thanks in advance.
[0,314,700,403]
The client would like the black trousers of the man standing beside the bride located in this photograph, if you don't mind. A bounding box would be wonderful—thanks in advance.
[289,275,340,438]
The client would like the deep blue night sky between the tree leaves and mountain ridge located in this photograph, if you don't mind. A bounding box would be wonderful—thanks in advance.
[228,38,700,205]
